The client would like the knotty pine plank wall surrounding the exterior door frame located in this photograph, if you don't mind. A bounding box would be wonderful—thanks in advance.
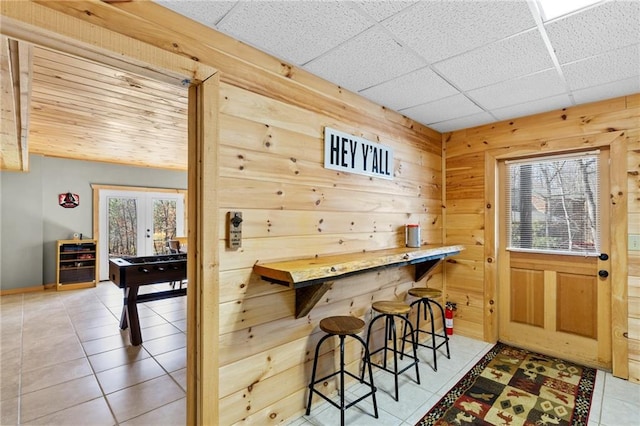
[443,95,640,382]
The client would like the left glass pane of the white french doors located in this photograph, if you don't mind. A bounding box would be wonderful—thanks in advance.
[108,197,138,259]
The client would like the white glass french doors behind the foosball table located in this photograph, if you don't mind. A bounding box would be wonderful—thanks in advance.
[99,190,185,280]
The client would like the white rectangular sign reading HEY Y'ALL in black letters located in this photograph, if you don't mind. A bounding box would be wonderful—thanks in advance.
[324,127,393,180]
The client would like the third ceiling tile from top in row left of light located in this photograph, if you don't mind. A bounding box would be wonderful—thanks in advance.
[467,68,567,109]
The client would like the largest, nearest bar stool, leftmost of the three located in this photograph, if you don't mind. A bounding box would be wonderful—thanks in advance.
[306,316,378,425]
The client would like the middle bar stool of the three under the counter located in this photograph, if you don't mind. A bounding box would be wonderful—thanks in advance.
[362,301,420,401]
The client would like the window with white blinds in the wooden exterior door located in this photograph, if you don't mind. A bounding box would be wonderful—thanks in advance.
[505,152,600,255]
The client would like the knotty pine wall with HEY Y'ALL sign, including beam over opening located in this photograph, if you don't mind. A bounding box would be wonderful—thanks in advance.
[2,1,443,425]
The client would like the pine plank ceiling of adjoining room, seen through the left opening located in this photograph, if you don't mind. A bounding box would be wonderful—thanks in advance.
[28,47,188,170]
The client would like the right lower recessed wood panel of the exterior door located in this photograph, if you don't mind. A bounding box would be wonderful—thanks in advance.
[556,273,598,339]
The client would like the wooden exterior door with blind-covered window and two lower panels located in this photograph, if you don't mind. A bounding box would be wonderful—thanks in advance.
[498,150,612,369]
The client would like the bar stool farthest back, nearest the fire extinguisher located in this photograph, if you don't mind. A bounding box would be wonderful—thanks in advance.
[402,287,451,371]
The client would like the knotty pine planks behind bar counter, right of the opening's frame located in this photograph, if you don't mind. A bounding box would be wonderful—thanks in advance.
[218,84,442,424]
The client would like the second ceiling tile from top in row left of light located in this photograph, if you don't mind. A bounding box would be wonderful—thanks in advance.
[434,30,553,90]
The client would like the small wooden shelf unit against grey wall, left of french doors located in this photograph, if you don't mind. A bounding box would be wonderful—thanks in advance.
[56,240,97,290]
